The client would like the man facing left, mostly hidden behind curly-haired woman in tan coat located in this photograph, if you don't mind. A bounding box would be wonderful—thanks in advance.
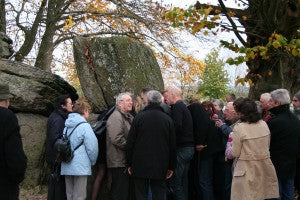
[216,102,238,200]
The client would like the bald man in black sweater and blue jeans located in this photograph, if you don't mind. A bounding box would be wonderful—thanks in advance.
[164,86,194,200]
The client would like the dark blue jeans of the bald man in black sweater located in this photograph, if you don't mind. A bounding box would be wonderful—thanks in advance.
[170,147,194,200]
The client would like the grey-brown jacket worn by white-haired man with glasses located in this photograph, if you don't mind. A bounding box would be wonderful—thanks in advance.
[106,109,133,168]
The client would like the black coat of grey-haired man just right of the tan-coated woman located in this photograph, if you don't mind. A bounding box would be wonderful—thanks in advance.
[267,105,300,179]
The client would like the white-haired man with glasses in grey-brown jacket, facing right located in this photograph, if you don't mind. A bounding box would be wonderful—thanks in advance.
[106,93,133,200]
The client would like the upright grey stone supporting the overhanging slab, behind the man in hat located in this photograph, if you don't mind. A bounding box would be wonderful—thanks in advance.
[16,113,48,188]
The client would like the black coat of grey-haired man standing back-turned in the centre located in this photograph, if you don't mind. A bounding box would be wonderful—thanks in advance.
[126,105,176,179]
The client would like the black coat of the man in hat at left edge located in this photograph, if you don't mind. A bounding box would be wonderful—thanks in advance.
[0,107,27,187]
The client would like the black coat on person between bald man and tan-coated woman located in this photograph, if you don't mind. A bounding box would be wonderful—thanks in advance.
[188,103,225,157]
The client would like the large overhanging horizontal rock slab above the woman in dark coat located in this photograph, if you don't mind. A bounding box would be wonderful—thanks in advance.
[0,59,78,116]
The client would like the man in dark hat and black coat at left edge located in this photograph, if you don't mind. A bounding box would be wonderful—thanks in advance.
[0,84,27,200]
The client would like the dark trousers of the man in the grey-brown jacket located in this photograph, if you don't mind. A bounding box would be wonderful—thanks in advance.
[109,167,129,200]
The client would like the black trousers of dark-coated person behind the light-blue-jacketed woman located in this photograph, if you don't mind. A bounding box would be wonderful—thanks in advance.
[47,165,67,200]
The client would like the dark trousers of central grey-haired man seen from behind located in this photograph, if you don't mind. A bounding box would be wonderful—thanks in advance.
[134,178,167,200]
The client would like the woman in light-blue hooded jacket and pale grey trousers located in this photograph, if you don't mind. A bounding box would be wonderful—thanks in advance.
[61,100,98,200]
